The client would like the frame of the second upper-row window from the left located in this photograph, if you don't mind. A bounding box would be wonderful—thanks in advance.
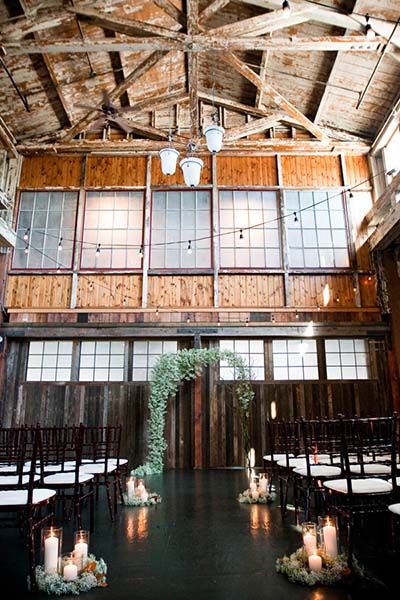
[78,187,146,273]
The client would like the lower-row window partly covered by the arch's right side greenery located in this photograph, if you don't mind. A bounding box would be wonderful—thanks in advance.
[219,340,265,381]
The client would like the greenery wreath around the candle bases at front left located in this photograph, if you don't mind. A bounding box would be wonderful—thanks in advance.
[36,554,107,596]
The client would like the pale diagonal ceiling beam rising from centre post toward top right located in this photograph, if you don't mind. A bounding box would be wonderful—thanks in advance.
[208,5,313,37]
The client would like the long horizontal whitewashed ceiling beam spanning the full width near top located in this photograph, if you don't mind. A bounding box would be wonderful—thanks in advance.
[2,35,388,56]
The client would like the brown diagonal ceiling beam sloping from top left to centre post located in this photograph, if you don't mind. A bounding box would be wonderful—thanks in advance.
[67,7,185,41]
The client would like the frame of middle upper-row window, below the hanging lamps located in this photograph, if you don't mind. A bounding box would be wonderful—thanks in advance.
[148,186,215,275]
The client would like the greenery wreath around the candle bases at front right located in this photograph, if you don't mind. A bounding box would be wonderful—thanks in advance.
[276,547,351,586]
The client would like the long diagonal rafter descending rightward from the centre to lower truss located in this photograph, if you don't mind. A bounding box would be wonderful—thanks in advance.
[221,52,327,141]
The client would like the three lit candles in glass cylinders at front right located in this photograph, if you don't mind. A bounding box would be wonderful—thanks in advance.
[302,517,338,571]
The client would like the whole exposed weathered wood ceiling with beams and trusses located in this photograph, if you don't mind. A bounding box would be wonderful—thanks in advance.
[0,0,400,152]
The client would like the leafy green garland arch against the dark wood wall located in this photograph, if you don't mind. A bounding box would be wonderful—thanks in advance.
[132,348,254,476]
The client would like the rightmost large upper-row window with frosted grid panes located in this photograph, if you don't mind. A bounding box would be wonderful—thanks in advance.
[285,191,349,268]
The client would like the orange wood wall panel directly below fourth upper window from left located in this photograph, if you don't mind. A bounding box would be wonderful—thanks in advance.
[219,274,284,308]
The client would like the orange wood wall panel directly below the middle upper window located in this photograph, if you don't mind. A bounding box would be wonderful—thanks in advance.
[148,275,214,310]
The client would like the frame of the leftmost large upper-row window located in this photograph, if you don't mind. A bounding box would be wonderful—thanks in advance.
[10,188,80,273]
